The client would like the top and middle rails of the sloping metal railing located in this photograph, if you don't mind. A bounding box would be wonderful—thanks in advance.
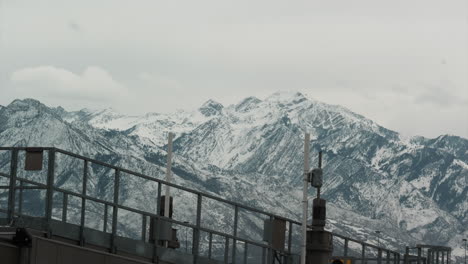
[0,147,406,260]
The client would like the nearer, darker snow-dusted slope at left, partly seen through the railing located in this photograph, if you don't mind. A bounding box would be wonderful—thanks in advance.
[0,99,314,254]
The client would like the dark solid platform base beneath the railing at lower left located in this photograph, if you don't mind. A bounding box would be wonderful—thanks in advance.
[0,225,205,264]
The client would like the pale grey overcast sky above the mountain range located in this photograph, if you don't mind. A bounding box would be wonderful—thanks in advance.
[0,0,468,138]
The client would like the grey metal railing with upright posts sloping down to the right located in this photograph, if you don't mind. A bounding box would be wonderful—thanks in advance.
[0,147,402,264]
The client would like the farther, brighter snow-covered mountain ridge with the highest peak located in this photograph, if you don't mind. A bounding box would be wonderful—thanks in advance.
[0,93,468,260]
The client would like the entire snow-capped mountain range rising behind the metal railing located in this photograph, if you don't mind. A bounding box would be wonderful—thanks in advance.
[0,92,468,262]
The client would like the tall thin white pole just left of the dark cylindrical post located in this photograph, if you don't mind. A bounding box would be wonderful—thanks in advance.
[301,133,310,264]
